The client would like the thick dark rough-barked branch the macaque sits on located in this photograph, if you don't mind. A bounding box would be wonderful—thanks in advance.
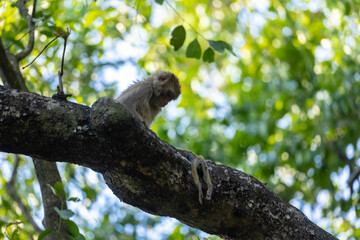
[0,86,336,240]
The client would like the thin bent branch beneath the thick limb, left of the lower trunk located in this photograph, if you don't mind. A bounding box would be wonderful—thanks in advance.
[5,155,41,233]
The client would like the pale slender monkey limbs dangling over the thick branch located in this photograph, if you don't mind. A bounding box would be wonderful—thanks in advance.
[181,150,213,204]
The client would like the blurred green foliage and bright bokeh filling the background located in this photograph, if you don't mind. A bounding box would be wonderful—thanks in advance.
[0,0,360,239]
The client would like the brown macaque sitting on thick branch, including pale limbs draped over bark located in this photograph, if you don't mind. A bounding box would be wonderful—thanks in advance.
[116,71,213,204]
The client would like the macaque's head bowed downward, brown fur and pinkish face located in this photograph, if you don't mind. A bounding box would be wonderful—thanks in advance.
[150,71,181,108]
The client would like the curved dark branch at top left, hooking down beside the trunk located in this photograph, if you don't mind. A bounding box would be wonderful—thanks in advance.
[15,0,36,62]
